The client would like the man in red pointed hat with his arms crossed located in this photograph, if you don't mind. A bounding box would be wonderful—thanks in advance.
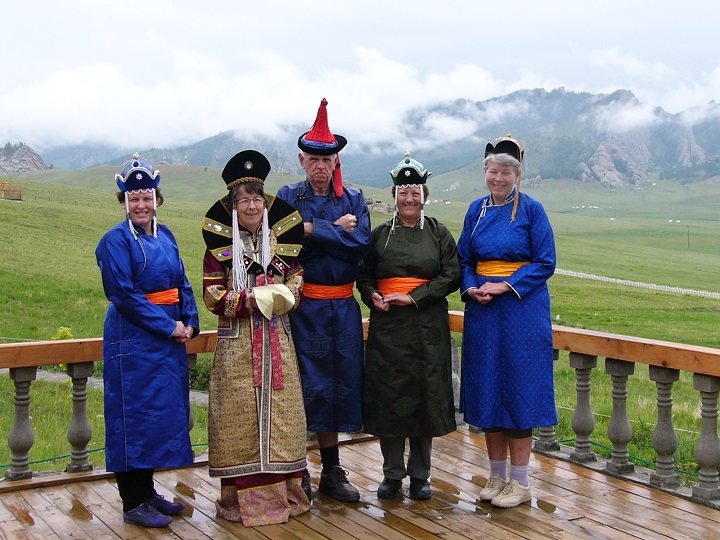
[277,99,371,502]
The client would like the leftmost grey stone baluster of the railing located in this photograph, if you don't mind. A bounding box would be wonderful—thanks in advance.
[5,366,37,480]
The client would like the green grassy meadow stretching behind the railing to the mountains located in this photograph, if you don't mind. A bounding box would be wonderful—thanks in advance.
[0,166,720,470]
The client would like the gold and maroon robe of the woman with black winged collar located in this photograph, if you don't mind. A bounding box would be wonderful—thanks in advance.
[203,227,310,525]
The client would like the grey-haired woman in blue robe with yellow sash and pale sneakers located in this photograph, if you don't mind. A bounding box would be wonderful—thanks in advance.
[458,136,557,508]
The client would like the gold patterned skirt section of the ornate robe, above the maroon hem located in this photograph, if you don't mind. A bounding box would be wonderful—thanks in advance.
[209,275,307,476]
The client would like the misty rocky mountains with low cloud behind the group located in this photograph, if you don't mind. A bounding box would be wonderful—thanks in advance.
[9,88,720,189]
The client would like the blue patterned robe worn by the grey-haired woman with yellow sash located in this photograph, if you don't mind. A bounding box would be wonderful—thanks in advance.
[458,193,557,429]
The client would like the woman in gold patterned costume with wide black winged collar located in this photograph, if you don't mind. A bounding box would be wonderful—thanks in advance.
[203,150,310,526]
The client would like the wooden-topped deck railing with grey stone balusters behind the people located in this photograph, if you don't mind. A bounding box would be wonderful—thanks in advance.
[0,311,720,508]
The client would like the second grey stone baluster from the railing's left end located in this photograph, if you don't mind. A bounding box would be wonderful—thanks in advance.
[65,362,93,472]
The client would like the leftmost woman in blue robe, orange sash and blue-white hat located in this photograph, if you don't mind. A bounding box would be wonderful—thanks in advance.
[95,154,200,527]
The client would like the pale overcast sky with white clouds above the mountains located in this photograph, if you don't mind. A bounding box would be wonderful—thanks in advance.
[0,0,720,150]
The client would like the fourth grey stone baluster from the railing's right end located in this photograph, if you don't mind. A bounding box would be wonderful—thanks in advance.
[570,352,597,463]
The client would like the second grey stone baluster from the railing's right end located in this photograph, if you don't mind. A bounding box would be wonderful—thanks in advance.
[650,366,680,489]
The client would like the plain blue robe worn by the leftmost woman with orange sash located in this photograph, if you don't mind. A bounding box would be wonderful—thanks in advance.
[95,221,200,472]
